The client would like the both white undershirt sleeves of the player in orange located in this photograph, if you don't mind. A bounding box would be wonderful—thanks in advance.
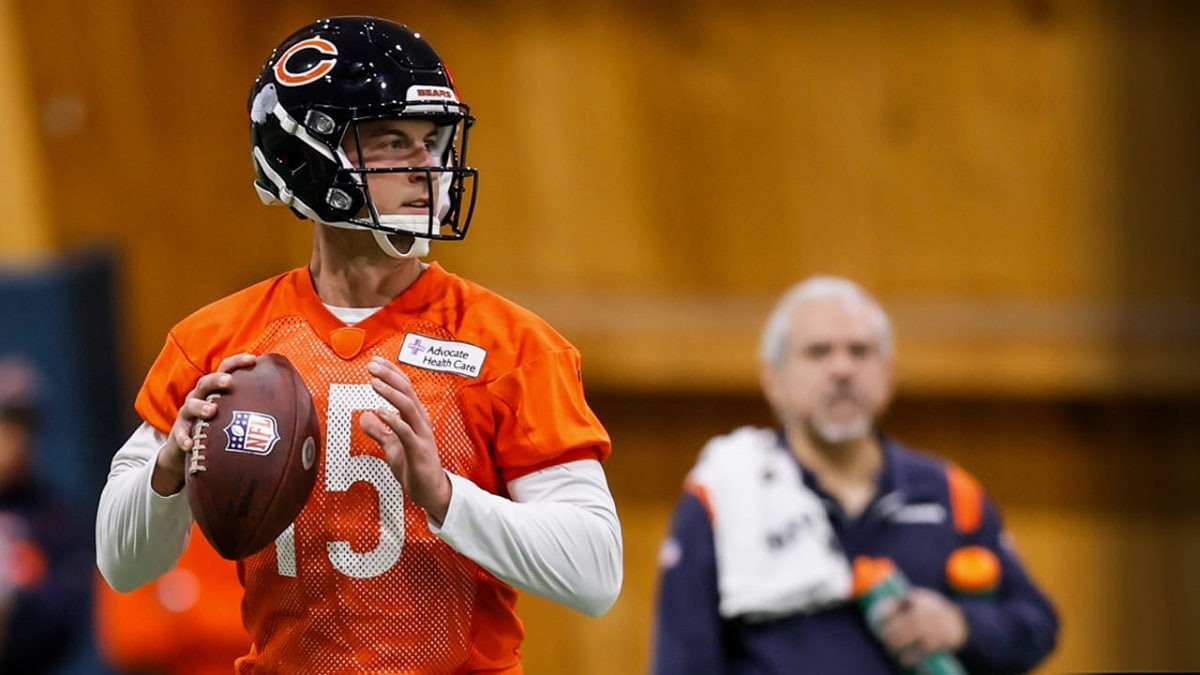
[96,423,623,616]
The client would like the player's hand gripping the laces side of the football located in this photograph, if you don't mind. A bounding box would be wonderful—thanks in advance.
[150,354,258,496]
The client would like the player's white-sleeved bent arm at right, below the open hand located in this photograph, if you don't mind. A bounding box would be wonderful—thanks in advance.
[436,460,623,616]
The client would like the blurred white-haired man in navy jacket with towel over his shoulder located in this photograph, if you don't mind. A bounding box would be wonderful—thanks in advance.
[653,276,1058,675]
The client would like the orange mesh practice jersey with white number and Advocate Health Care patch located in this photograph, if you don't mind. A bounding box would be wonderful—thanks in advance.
[136,263,610,675]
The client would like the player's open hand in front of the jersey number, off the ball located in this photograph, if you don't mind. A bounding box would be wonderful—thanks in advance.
[359,357,451,524]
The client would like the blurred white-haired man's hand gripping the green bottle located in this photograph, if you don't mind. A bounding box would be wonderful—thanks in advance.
[881,587,967,668]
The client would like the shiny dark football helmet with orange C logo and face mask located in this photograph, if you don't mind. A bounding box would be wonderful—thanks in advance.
[250,17,478,257]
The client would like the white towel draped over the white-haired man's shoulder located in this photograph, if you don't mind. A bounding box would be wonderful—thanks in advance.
[688,426,851,621]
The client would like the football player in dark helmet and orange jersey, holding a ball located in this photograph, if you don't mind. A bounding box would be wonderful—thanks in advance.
[96,17,623,674]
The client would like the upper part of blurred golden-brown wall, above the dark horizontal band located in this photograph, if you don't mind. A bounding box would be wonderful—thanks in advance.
[11,0,1200,392]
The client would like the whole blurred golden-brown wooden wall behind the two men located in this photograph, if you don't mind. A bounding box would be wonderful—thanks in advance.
[0,0,1200,675]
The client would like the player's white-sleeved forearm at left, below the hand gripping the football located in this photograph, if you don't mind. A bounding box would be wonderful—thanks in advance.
[96,425,192,591]
